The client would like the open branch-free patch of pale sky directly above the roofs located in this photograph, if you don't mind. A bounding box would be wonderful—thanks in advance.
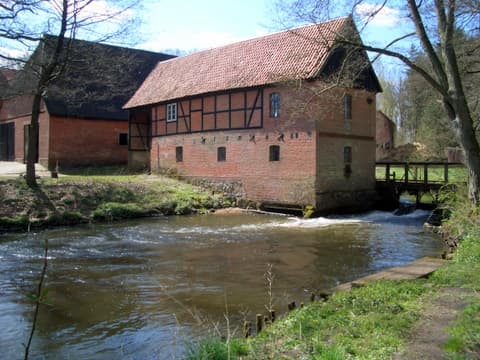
[137,0,278,51]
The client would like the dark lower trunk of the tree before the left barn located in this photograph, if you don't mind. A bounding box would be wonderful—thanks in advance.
[25,93,42,187]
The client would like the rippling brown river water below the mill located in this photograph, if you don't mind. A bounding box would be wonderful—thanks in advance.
[0,210,443,359]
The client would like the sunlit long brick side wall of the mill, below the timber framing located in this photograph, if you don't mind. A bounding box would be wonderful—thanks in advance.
[151,130,315,204]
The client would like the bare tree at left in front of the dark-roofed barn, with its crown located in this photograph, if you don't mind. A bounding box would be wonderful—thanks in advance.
[0,0,138,186]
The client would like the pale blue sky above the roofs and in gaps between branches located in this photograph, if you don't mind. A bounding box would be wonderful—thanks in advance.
[0,0,406,77]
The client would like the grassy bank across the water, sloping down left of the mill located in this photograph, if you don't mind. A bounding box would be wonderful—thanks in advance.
[0,170,232,231]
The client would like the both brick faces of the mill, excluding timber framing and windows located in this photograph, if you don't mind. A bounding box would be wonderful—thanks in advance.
[146,82,375,210]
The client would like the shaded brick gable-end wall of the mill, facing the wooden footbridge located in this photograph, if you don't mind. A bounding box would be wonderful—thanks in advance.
[316,89,376,211]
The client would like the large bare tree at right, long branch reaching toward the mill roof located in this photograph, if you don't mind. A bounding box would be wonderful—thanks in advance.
[278,0,480,204]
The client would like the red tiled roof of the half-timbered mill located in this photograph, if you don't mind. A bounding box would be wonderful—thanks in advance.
[125,17,349,108]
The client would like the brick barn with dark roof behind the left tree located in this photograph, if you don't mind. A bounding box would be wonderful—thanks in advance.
[0,36,173,169]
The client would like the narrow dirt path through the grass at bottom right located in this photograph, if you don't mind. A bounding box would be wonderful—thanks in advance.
[395,288,478,360]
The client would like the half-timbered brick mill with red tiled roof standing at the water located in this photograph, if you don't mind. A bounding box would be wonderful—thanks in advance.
[125,18,380,211]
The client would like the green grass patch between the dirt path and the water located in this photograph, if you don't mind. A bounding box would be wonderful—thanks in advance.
[252,281,429,359]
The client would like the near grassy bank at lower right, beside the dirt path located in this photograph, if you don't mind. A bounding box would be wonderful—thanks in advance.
[188,187,480,359]
